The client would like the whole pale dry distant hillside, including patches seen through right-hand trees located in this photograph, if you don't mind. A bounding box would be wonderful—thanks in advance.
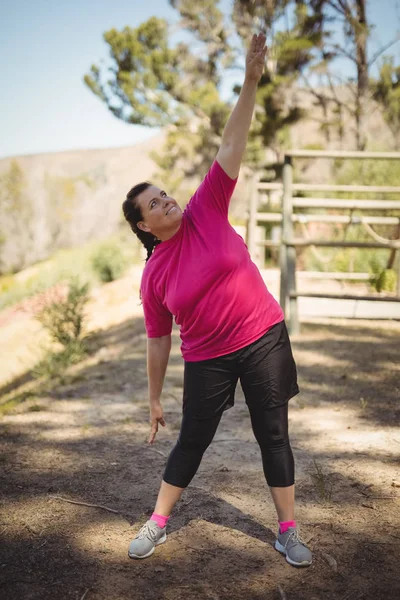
[0,89,393,273]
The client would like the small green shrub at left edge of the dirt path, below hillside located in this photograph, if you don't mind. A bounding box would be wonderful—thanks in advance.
[36,278,89,346]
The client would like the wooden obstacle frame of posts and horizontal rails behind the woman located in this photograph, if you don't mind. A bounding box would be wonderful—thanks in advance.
[247,150,400,333]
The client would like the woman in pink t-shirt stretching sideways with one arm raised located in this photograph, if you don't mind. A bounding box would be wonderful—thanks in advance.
[123,34,312,566]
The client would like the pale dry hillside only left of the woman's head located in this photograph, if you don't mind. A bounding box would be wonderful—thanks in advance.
[0,133,165,272]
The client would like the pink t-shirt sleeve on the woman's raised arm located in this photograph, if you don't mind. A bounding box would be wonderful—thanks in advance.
[187,160,237,217]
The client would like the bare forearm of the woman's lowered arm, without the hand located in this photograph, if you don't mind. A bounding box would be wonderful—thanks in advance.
[147,335,171,404]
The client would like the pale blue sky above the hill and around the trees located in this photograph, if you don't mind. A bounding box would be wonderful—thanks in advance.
[0,0,400,158]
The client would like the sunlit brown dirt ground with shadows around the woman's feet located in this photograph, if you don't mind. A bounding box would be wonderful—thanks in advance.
[0,270,400,600]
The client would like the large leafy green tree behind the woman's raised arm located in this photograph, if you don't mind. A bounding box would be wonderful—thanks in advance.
[84,0,322,189]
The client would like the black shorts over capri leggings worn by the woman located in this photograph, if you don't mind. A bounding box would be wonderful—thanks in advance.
[163,321,299,488]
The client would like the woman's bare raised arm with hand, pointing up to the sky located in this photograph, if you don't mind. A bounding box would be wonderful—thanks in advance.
[216,33,267,179]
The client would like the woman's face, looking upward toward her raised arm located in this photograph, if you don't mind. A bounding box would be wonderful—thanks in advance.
[136,185,182,241]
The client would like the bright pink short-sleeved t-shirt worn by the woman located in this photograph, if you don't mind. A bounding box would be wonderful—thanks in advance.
[141,161,283,362]
